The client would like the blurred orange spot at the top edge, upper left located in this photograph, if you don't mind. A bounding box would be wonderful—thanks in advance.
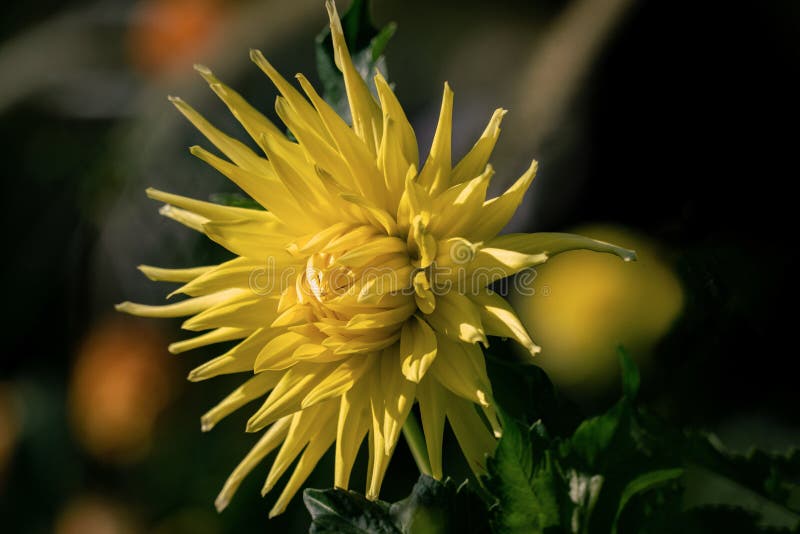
[127,0,226,75]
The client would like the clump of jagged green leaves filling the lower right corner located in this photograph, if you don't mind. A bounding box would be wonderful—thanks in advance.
[486,350,800,533]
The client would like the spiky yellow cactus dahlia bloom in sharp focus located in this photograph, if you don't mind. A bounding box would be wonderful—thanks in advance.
[118,1,633,516]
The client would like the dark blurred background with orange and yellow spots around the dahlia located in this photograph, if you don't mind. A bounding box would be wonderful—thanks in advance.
[0,0,800,534]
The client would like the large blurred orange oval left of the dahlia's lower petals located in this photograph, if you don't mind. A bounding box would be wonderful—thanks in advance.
[69,318,175,462]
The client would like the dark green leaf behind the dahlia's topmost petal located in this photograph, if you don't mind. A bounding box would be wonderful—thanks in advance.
[316,0,397,122]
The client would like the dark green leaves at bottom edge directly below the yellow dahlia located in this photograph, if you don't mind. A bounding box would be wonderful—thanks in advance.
[303,475,489,534]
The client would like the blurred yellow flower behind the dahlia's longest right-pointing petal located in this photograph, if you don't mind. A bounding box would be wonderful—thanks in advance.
[510,225,684,397]
